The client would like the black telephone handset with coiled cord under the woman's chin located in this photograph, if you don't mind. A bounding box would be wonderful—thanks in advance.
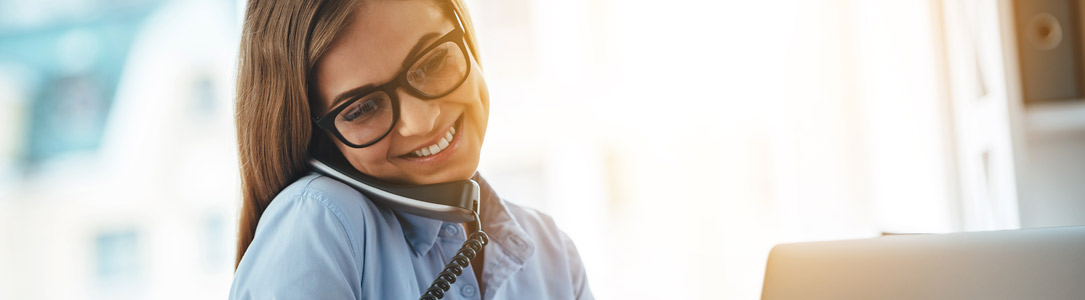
[309,141,489,300]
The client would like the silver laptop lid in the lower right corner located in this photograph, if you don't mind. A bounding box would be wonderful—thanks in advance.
[762,226,1085,300]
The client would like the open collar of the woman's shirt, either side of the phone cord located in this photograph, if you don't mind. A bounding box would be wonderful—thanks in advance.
[396,172,535,263]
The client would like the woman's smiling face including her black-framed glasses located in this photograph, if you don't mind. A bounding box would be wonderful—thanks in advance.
[312,1,489,184]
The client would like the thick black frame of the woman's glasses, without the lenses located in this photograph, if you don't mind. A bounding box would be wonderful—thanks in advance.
[312,12,473,148]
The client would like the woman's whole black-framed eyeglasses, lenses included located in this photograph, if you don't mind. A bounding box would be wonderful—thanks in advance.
[312,12,471,148]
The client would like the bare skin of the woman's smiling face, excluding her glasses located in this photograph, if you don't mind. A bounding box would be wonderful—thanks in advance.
[312,1,489,184]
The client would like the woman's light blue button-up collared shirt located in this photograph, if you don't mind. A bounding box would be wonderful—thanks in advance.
[230,174,593,300]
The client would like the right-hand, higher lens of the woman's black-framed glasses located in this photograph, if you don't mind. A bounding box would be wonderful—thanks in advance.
[407,41,468,96]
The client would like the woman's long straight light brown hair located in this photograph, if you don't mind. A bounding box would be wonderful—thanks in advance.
[234,0,480,267]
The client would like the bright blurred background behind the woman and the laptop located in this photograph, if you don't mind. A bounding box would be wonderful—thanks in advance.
[0,0,1085,299]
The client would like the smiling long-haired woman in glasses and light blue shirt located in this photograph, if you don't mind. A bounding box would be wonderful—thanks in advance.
[230,0,592,299]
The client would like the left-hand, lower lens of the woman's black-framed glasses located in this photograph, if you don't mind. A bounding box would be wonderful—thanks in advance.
[335,91,393,145]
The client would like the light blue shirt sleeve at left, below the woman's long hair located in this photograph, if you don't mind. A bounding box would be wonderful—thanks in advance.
[230,192,361,300]
